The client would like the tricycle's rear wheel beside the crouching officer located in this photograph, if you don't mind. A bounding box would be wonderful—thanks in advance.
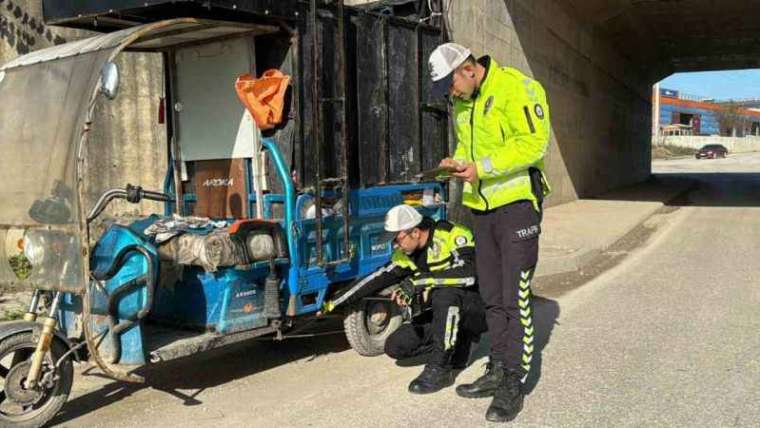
[343,294,404,357]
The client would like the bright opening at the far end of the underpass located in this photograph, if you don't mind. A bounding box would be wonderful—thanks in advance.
[652,69,760,210]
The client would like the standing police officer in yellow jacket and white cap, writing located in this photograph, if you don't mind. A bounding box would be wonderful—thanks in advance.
[429,43,550,422]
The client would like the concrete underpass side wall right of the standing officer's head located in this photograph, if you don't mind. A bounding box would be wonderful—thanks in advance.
[450,0,651,204]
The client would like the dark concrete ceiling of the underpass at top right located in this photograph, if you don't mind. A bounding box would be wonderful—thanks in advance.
[568,0,760,74]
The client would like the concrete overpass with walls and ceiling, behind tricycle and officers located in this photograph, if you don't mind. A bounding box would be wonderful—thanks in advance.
[0,0,760,204]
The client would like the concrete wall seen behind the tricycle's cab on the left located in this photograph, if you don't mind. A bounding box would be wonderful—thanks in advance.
[0,0,167,215]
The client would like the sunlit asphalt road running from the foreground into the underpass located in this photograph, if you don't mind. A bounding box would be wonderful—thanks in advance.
[50,154,760,427]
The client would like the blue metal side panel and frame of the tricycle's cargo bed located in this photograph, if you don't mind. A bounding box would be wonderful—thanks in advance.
[159,138,446,315]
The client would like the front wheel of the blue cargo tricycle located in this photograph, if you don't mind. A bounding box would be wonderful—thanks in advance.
[0,333,74,428]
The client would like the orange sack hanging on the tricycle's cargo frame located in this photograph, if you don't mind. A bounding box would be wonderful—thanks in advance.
[235,69,290,130]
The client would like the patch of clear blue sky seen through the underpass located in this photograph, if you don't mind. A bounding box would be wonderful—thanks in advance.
[660,69,760,99]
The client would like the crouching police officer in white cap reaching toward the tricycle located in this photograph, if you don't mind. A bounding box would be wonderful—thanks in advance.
[323,205,486,394]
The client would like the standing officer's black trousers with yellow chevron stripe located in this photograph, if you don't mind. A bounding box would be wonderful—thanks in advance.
[473,201,541,379]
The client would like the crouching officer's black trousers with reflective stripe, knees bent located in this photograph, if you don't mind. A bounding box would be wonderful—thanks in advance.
[385,287,487,367]
